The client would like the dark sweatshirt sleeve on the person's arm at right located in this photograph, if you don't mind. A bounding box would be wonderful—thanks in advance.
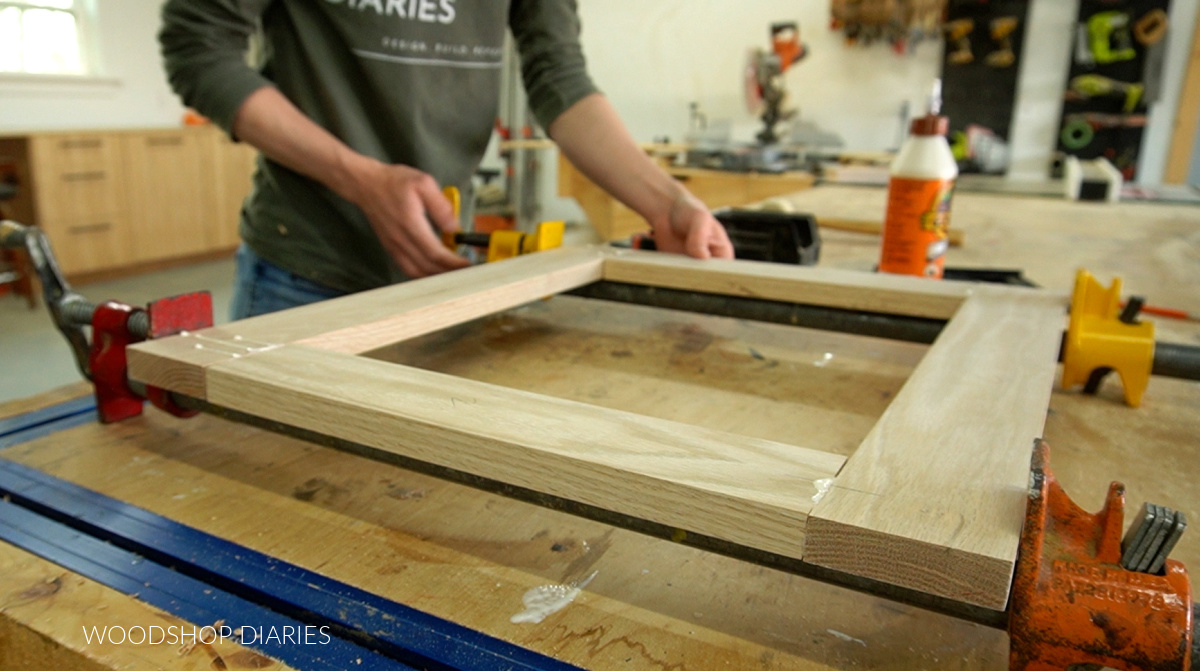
[509,0,598,128]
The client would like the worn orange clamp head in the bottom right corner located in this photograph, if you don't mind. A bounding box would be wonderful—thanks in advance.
[1008,442,1194,671]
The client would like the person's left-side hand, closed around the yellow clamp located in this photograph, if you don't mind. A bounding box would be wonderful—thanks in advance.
[352,163,469,278]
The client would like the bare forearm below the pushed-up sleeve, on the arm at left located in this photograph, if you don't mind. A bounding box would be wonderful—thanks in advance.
[233,86,382,202]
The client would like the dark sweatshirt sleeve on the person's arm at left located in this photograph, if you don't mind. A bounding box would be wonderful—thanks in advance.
[158,0,271,136]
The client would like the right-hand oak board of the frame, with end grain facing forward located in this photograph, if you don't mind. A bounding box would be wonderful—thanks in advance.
[805,287,1066,610]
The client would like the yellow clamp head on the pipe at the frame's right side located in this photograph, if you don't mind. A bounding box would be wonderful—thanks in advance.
[1062,270,1154,408]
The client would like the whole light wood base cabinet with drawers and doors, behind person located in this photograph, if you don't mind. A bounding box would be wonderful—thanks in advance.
[0,127,256,276]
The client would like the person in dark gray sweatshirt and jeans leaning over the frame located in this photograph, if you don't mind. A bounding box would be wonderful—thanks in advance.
[158,0,733,318]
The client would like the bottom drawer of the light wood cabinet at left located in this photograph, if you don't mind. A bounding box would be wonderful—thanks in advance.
[43,216,132,275]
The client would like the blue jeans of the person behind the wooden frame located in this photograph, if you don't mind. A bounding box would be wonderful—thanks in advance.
[229,242,346,320]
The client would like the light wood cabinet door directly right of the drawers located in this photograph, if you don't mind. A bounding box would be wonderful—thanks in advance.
[121,128,211,262]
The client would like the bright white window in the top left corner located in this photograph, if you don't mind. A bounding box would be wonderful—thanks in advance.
[0,0,88,74]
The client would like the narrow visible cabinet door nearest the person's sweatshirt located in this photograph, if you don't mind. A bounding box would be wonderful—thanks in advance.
[206,128,258,250]
